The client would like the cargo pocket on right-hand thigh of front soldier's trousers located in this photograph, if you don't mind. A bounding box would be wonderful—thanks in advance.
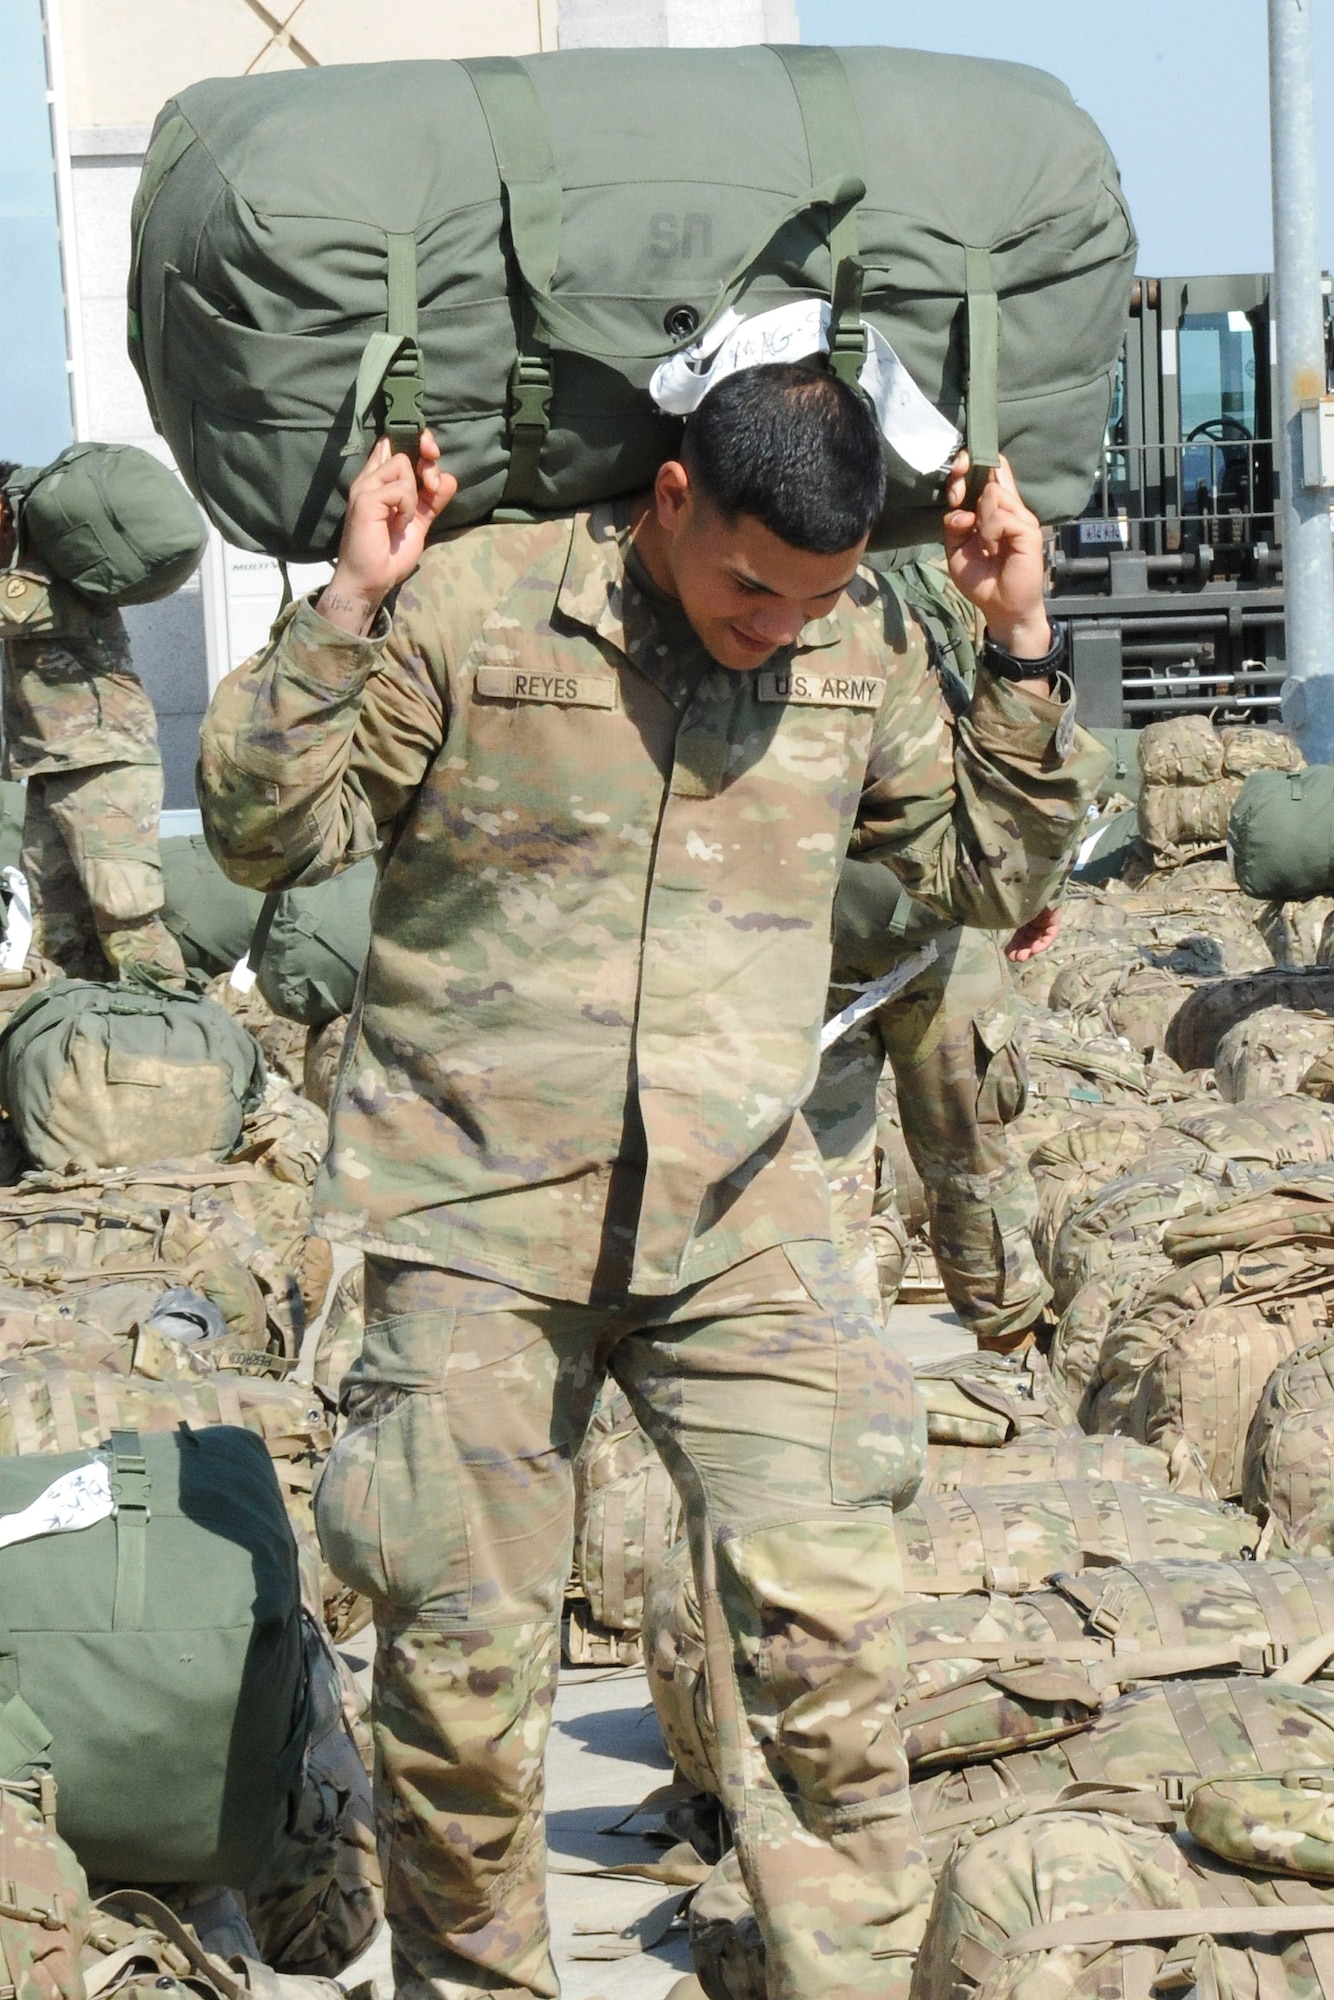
[784,1242,926,1508]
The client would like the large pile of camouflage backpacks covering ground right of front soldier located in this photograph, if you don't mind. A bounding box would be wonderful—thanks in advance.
[576,718,1334,2000]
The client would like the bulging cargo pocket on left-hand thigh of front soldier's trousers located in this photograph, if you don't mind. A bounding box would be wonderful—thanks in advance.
[314,1312,472,1618]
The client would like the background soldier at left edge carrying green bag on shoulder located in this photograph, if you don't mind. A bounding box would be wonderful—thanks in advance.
[0,466,186,986]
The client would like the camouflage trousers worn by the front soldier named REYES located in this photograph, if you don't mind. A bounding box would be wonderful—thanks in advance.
[316,1242,930,2000]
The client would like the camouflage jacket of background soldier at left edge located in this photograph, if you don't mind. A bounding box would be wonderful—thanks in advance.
[0,566,160,778]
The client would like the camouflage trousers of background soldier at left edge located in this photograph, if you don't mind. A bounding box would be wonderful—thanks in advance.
[20,764,186,986]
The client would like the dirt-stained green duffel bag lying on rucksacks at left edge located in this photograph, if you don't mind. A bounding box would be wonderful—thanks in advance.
[0,980,264,1172]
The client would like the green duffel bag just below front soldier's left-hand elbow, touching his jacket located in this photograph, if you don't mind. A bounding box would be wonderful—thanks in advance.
[260,862,376,1028]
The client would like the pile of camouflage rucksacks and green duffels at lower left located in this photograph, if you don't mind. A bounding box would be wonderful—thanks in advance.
[0,964,384,2000]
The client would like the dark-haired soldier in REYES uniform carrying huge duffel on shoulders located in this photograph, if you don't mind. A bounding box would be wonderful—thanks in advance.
[200,366,1102,2000]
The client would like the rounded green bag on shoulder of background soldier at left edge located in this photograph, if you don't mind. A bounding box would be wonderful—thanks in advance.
[2,444,208,608]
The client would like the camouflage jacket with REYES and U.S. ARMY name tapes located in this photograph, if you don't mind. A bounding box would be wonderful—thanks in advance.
[200,506,1102,1300]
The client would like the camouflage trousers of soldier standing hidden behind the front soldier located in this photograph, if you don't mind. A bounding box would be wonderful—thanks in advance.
[804,928,1050,1348]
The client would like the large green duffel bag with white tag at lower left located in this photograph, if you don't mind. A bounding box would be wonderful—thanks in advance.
[0,1424,308,1888]
